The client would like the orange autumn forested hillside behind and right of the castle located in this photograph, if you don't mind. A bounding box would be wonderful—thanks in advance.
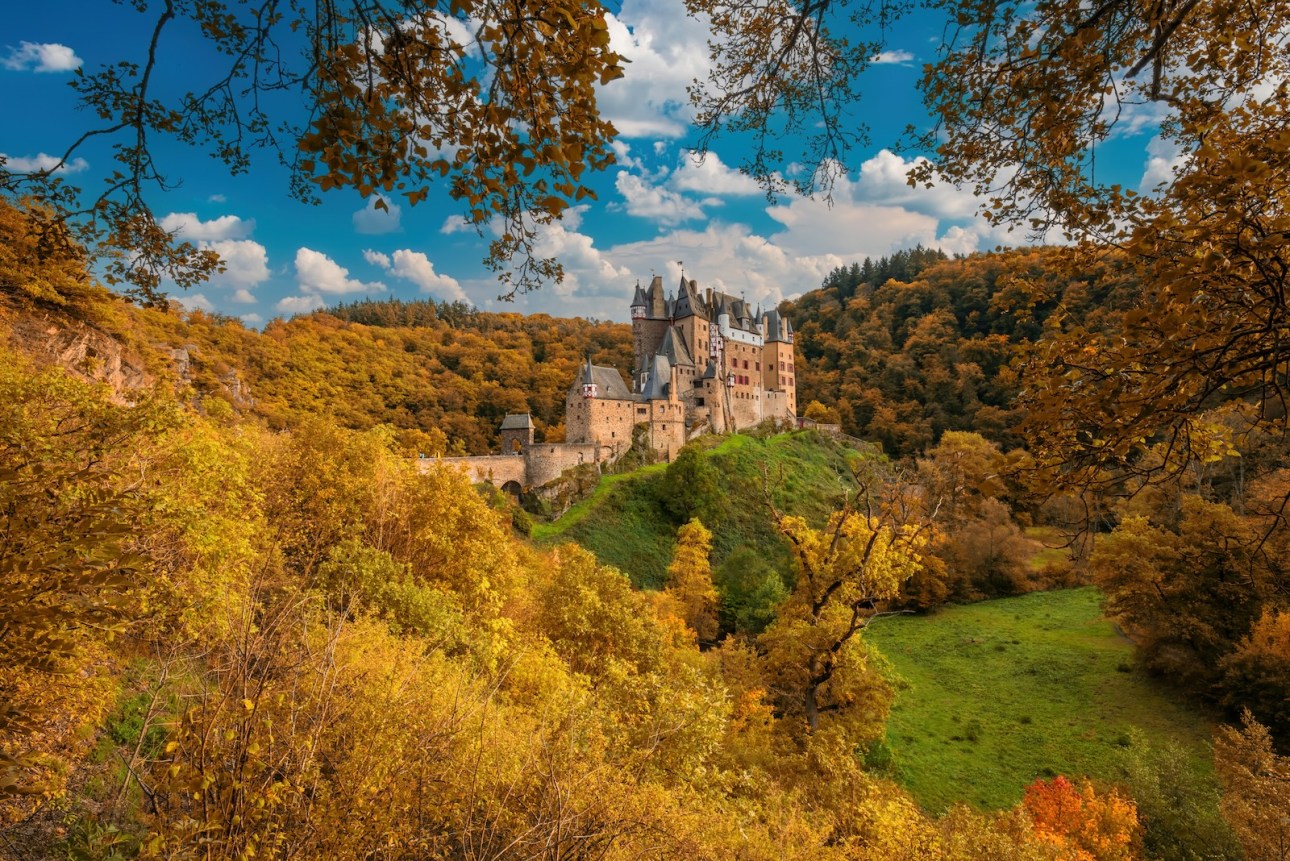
[783,249,1131,456]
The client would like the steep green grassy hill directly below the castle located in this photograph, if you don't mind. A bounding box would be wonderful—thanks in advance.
[533,431,854,589]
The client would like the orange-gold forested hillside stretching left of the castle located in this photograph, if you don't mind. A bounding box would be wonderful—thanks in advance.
[0,205,632,454]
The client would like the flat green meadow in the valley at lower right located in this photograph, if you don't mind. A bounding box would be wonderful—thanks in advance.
[867,587,1213,812]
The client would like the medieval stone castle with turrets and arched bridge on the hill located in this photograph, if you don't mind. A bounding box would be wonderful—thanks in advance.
[433,275,797,493]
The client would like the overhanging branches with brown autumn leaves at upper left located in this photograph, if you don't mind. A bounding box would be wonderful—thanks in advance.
[0,0,622,302]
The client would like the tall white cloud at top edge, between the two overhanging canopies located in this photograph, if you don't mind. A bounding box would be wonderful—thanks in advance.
[596,0,711,138]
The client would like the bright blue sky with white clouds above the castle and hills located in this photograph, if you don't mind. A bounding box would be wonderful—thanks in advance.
[0,0,1170,325]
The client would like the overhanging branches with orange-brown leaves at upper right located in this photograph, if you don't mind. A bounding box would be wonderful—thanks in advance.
[691,0,1290,483]
